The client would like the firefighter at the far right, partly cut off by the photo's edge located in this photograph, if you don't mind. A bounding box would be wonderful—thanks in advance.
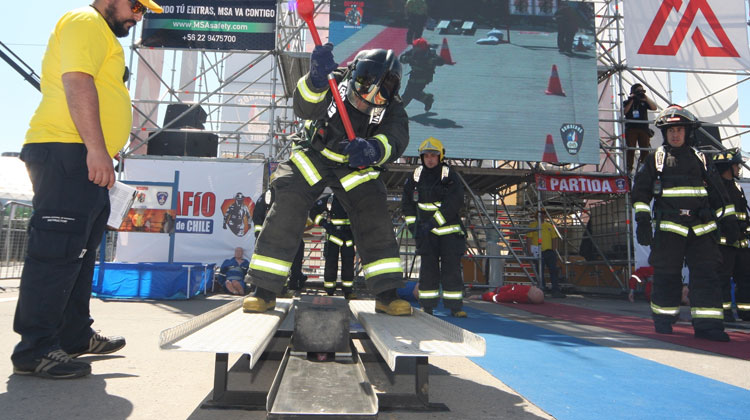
[713,148,750,322]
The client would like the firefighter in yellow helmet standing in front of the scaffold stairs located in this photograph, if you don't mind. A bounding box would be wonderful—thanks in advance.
[401,137,466,318]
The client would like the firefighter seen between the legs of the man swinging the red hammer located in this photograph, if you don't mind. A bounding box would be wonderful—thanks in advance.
[310,194,356,300]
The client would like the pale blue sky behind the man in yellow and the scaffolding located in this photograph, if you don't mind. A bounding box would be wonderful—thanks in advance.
[0,0,750,156]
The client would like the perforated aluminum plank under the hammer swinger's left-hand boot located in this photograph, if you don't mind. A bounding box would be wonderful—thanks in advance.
[159,298,292,369]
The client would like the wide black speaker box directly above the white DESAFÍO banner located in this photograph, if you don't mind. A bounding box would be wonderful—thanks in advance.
[146,128,219,157]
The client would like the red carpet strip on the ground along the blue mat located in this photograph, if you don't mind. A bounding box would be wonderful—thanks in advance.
[501,302,750,360]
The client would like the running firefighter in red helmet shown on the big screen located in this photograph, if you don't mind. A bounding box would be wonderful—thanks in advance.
[400,38,445,111]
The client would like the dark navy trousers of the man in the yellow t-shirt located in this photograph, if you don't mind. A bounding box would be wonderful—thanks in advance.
[11,143,109,362]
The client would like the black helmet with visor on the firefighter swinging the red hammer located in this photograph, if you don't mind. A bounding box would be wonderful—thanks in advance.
[346,49,401,115]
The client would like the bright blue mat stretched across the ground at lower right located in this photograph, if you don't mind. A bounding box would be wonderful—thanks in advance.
[435,307,750,420]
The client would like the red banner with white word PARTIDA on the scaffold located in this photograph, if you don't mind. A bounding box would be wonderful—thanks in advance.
[535,174,630,194]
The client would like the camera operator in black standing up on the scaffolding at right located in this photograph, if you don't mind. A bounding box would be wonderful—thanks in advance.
[622,83,656,174]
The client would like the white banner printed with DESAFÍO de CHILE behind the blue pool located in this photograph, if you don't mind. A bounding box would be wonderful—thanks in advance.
[115,159,263,264]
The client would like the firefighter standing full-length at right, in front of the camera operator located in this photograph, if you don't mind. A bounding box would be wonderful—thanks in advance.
[632,105,738,341]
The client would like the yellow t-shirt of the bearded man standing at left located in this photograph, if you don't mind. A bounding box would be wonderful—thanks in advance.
[25,6,132,156]
